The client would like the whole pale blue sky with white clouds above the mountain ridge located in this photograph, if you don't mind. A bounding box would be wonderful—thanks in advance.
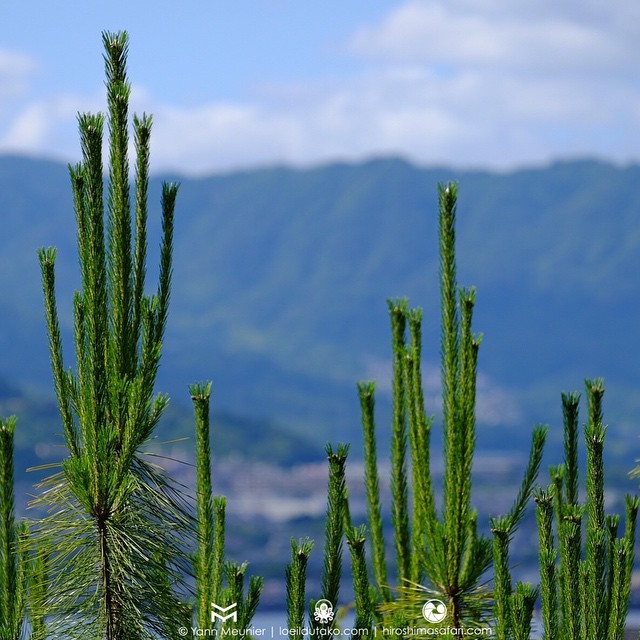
[0,0,640,175]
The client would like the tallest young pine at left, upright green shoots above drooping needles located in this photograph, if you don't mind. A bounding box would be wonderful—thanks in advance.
[34,32,193,640]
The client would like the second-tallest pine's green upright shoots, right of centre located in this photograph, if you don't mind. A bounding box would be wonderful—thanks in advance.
[359,183,546,630]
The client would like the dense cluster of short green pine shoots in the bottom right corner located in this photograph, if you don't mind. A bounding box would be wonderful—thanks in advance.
[500,380,640,640]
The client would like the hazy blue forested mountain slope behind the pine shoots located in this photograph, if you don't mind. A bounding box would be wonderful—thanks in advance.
[0,157,640,448]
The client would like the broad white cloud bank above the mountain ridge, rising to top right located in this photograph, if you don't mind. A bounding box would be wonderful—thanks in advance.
[0,0,640,174]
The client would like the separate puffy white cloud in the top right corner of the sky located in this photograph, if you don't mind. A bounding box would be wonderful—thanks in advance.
[350,0,640,74]
